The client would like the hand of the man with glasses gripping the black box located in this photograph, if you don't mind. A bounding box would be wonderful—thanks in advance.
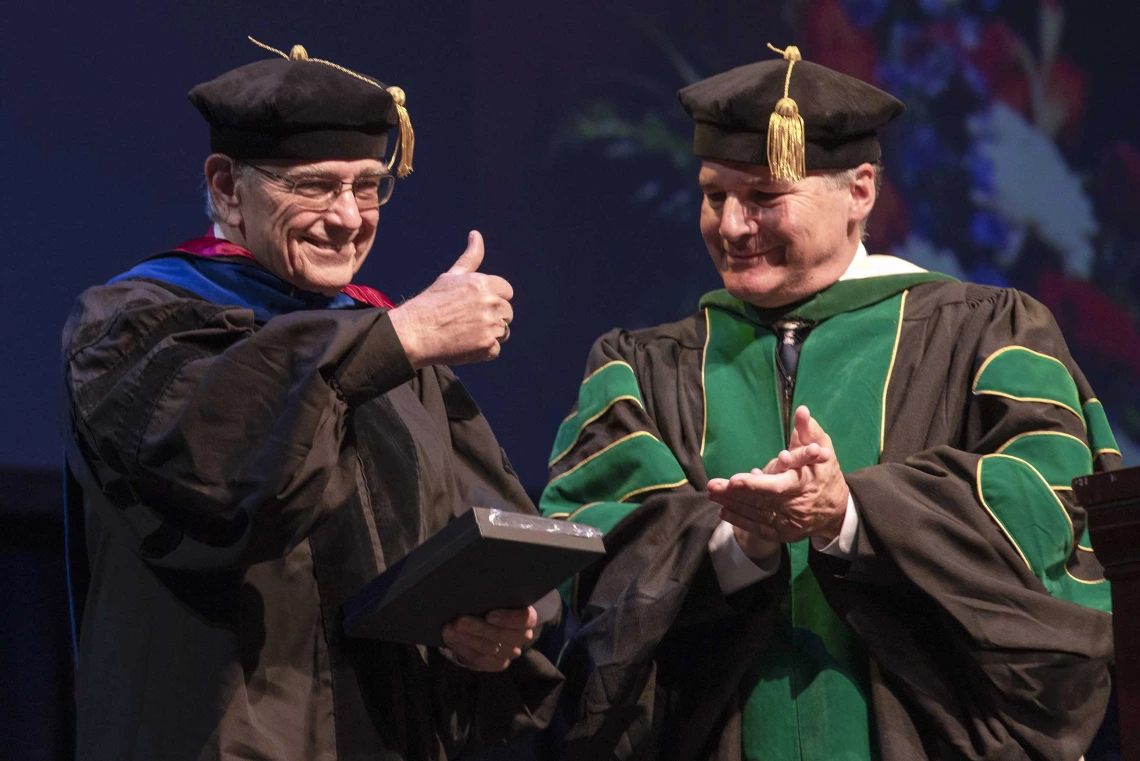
[442,606,538,671]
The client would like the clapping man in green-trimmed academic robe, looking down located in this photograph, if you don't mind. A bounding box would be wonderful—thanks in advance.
[540,48,1119,761]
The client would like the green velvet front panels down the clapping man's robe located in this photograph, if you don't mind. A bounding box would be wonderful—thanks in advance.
[702,293,903,761]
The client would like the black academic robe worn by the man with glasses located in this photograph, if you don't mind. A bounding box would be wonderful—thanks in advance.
[63,279,561,761]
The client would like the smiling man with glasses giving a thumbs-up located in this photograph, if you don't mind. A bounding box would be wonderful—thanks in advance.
[63,46,561,760]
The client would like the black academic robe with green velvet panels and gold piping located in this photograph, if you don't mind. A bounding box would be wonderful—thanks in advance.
[540,264,1119,761]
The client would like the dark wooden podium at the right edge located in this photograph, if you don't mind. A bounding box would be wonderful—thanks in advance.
[1073,467,1140,759]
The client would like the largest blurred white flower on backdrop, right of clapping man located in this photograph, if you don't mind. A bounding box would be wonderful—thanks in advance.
[967,103,1097,278]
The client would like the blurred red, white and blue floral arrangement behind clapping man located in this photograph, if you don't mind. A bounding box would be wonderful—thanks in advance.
[553,0,1140,464]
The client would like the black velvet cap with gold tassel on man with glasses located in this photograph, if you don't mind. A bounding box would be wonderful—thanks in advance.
[189,38,415,177]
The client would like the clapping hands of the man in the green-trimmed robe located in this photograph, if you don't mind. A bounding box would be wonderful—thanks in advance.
[708,407,849,542]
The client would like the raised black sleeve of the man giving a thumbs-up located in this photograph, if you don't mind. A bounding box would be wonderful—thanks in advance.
[64,280,415,568]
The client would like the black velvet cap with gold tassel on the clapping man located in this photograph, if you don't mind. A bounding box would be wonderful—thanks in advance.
[677,46,905,181]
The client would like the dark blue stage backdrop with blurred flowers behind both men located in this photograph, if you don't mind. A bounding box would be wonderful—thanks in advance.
[0,0,1140,759]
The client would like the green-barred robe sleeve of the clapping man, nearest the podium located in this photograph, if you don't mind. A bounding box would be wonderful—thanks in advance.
[811,291,1119,759]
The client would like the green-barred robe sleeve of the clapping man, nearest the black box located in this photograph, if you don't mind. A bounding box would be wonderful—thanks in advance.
[539,330,788,759]
